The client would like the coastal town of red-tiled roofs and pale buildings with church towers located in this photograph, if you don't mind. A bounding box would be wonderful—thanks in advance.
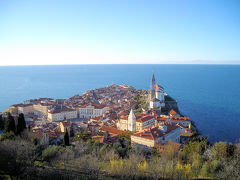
[2,74,193,151]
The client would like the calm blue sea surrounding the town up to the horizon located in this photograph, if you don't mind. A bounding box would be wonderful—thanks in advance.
[0,65,240,143]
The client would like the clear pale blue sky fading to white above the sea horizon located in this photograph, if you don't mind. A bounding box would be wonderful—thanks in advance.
[0,0,240,66]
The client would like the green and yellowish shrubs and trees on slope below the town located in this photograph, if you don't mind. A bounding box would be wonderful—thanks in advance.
[0,131,240,179]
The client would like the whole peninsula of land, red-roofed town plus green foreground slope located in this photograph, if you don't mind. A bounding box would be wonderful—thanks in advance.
[0,74,240,179]
